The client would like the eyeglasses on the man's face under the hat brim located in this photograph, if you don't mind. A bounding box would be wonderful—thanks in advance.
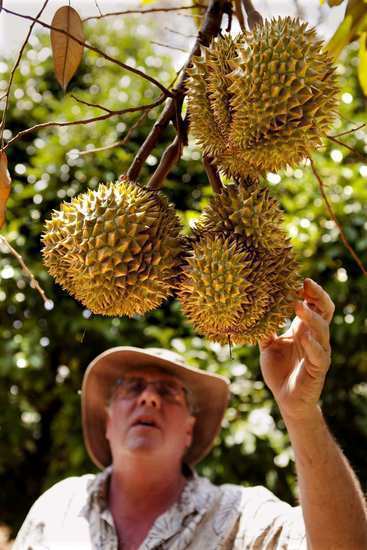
[112,376,187,403]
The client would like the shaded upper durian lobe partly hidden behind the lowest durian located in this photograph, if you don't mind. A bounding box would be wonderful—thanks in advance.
[197,178,286,250]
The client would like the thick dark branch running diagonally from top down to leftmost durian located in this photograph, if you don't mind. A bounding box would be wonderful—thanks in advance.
[127,0,229,185]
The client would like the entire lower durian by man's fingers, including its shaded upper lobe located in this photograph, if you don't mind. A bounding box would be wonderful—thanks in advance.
[178,181,301,344]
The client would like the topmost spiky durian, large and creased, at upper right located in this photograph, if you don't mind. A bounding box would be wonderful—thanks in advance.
[187,17,338,177]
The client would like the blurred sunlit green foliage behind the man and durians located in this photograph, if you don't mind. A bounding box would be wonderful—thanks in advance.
[0,0,367,544]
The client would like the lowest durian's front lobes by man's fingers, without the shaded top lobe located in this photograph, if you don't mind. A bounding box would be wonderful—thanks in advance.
[178,233,300,344]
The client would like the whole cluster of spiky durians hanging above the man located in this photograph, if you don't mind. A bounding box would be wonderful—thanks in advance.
[42,18,337,343]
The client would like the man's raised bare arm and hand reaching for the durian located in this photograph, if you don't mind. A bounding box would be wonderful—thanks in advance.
[259,279,367,550]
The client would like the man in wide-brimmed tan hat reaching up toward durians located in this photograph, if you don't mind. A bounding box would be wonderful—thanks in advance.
[14,279,367,550]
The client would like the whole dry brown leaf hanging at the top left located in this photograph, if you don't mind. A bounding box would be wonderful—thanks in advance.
[51,6,84,90]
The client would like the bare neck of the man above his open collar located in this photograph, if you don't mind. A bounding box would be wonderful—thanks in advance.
[108,459,186,548]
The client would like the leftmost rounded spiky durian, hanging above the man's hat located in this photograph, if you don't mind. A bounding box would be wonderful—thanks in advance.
[42,177,183,316]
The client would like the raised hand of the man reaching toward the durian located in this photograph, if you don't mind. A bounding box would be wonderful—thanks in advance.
[259,279,335,419]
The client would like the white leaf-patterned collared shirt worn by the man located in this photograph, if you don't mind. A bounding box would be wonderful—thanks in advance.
[13,467,307,550]
